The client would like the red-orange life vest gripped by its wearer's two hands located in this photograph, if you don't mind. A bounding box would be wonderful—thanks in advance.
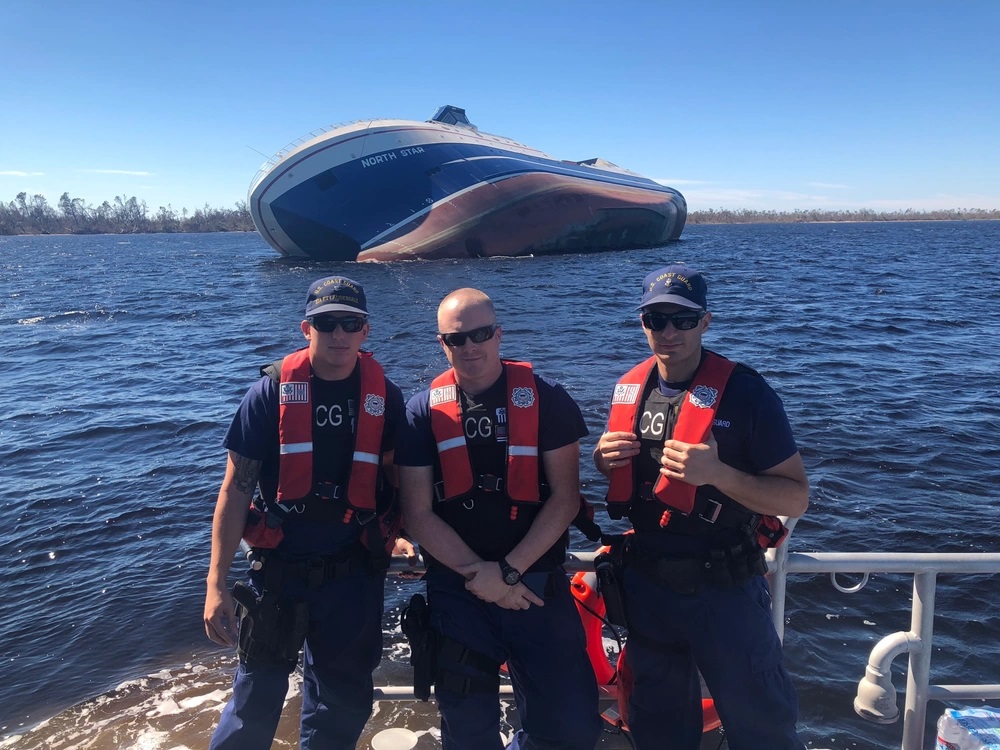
[607,351,736,513]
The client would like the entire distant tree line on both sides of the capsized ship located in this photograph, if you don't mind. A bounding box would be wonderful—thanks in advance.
[0,193,1000,235]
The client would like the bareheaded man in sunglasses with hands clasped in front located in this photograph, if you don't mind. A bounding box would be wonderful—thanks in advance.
[396,289,600,750]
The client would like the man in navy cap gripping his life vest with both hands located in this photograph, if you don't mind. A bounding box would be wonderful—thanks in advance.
[594,265,809,750]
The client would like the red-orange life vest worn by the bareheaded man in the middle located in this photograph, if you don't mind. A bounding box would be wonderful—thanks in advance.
[430,360,540,503]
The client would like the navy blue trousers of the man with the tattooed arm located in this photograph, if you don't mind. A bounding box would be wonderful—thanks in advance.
[209,571,385,750]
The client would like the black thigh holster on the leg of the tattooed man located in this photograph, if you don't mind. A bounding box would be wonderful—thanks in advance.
[233,581,309,672]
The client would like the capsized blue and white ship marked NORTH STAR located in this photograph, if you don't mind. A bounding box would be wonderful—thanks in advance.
[248,106,687,261]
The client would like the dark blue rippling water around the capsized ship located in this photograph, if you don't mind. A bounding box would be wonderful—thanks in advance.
[0,222,1000,748]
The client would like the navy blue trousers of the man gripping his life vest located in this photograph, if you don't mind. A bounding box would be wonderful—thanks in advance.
[625,568,805,750]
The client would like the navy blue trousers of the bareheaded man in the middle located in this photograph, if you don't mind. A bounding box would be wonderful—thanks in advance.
[425,566,601,750]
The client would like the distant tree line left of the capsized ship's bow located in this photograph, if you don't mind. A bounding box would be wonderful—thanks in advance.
[0,193,254,235]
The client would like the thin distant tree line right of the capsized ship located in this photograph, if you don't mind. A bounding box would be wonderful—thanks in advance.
[687,208,1000,224]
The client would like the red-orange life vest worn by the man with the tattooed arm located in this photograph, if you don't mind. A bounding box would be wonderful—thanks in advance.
[278,348,385,511]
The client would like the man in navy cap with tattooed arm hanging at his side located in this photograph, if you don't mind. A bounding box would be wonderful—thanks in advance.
[204,276,412,750]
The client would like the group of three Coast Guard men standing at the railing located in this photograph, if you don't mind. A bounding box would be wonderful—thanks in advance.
[205,266,809,750]
